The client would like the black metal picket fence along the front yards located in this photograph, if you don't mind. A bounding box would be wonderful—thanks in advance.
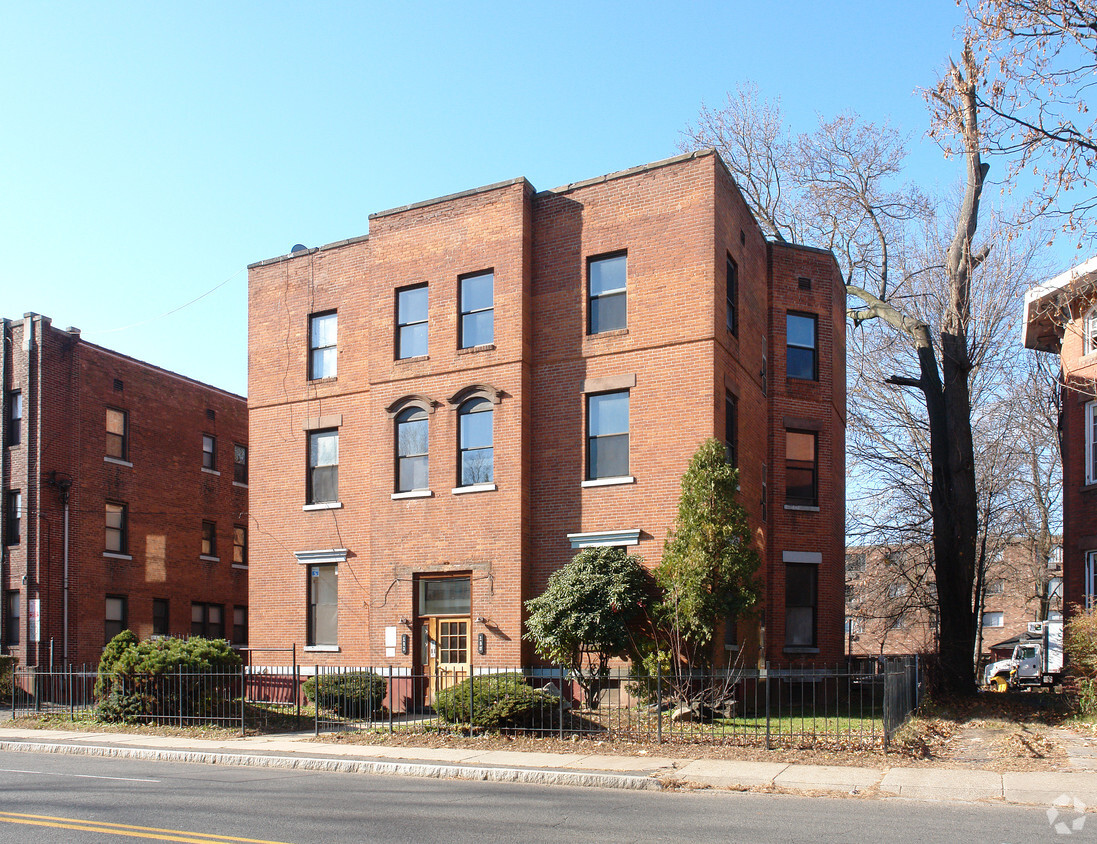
[0,660,919,747]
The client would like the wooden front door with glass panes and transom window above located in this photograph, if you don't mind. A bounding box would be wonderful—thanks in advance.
[418,577,472,706]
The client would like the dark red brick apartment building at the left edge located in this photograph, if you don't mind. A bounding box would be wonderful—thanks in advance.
[0,314,248,665]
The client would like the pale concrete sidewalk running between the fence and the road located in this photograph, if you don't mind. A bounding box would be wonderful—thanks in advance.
[0,729,1097,811]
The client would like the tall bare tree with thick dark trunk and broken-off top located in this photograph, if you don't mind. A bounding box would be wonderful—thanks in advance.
[687,45,1004,694]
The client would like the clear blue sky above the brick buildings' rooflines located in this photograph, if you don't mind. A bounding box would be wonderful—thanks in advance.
[0,0,1026,393]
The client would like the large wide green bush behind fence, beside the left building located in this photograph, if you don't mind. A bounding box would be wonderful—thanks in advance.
[95,630,240,722]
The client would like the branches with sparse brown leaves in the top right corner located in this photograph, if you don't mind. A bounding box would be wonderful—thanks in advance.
[968,0,1097,228]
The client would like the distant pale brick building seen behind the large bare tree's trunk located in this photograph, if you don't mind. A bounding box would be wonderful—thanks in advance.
[846,541,1063,656]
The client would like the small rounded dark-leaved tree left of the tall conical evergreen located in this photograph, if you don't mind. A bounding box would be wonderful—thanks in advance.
[525,548,646,708]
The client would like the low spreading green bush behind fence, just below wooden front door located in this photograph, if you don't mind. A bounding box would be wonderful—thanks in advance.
[434,674,559,730]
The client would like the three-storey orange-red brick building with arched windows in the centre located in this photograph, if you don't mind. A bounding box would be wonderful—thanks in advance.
[248,151,846,671]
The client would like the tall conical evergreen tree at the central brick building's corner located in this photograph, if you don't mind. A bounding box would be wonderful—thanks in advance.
[652,439,760,695]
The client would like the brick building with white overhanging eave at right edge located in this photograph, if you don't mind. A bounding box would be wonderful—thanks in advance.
[1024,258,1097,615]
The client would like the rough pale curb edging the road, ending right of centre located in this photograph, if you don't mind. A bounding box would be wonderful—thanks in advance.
[0,741,663,791]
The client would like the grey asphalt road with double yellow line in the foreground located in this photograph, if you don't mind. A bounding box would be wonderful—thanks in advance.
[0,753,1079,844]
